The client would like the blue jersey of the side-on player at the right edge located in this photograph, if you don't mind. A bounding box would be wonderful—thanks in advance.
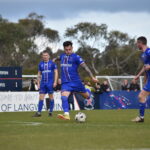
[141,48,150,79]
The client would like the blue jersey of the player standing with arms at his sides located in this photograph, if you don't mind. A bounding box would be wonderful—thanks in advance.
[38,60,57,84]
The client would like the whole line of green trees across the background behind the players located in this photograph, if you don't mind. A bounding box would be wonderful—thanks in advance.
[0,13,142,77]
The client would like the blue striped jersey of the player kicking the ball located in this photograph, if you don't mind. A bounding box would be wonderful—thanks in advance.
[60,53,84,83]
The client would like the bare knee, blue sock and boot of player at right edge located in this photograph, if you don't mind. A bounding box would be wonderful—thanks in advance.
[132,90,150,122]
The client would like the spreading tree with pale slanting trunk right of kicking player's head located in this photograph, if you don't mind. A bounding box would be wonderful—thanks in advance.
[65,22,107,74]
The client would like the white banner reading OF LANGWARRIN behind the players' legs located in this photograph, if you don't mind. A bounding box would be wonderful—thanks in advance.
[0,92,62,112]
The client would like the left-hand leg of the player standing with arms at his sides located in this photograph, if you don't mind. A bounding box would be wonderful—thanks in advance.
[33,94,45,117]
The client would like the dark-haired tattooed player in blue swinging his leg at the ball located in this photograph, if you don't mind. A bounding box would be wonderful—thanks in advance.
[54,41,97,120]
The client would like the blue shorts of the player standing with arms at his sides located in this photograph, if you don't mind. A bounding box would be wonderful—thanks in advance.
[39,83,54,94]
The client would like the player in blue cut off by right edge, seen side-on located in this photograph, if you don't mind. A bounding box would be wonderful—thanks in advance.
[132,36,150,122]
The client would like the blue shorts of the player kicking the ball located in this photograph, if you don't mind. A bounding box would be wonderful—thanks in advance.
[61,81,86,93]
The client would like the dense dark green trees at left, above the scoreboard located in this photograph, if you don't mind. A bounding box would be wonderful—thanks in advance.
[0,13,59,74]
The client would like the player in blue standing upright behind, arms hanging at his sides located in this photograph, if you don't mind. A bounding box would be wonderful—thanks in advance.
[33,51,58,117]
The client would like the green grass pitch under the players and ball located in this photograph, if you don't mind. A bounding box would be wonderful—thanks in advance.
[0,110,150,150]
